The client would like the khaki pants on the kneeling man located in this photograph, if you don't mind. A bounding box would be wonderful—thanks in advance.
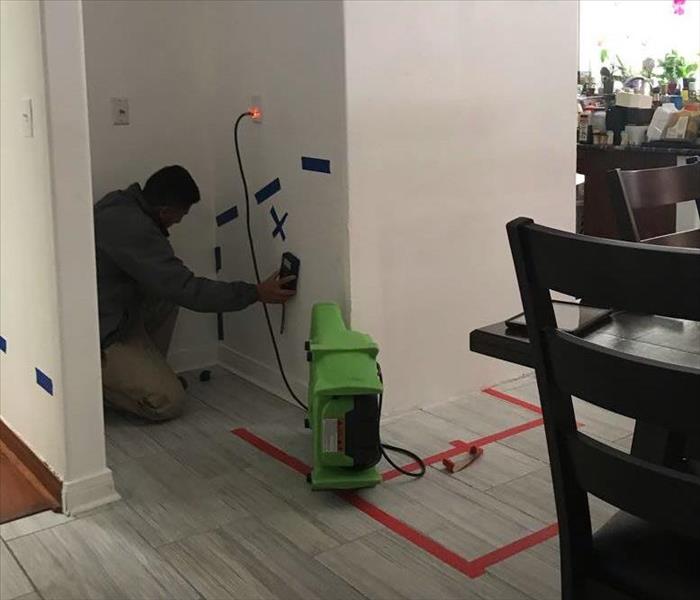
[102,300,186,421]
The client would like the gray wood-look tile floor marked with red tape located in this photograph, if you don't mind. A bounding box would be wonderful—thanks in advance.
[0,368,632,600]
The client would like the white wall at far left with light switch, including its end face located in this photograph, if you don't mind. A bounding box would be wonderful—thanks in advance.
[0,0,116,513]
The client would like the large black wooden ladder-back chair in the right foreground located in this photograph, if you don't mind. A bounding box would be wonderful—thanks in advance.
[507,218,700,600]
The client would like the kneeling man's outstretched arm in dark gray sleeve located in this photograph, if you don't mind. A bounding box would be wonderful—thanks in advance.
[96,208,258,312]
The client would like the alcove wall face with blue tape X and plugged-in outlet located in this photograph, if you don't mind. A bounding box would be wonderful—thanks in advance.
[207,1,349,397]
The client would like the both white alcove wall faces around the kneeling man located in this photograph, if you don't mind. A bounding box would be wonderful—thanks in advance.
[84,1,349,396]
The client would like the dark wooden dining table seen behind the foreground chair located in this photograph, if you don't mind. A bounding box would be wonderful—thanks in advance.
[469,312,700,465]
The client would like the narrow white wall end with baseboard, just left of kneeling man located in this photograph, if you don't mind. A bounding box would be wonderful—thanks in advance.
[43,0,118,513]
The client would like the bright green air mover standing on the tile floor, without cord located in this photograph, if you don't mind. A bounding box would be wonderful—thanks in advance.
[307,303,382,490]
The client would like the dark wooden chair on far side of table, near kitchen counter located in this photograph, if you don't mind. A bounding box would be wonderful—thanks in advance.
[608,162,700,242]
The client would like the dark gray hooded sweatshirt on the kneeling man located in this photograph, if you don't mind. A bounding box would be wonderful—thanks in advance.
[95,183,257,348]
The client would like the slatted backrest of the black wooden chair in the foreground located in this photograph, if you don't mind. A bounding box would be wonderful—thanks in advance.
[507,218,700,584]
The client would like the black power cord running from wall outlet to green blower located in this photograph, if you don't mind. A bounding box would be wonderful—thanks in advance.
[233,111,426,478]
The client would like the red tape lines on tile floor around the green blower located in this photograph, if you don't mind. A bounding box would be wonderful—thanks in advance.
[232,419,558,579]
